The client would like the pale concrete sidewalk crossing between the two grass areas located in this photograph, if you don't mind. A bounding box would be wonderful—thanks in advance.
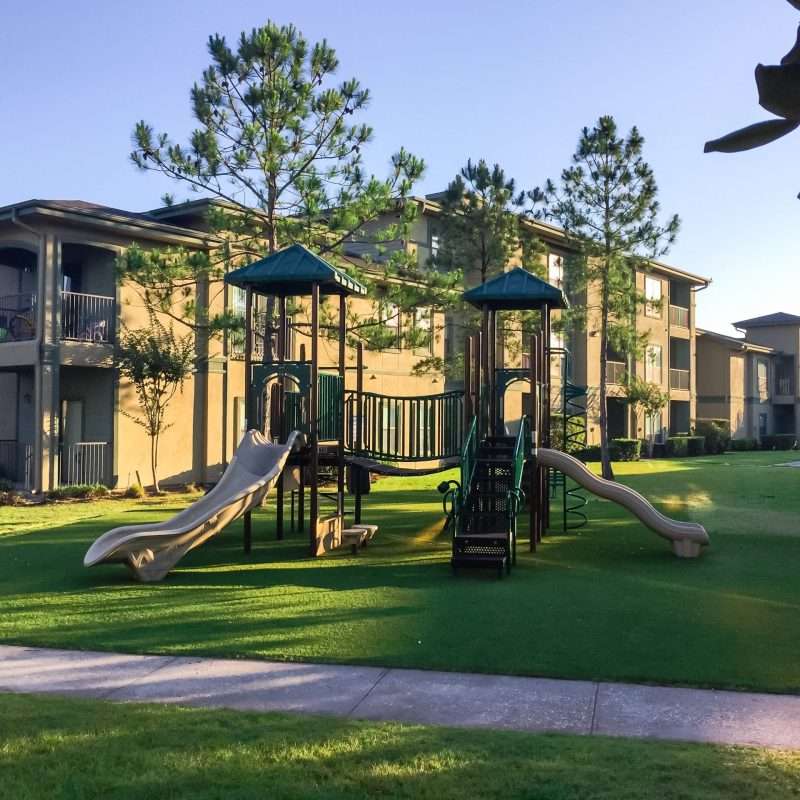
[0,646,800,749]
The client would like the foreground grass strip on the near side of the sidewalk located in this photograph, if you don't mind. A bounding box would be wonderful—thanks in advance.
[0,695,800,800]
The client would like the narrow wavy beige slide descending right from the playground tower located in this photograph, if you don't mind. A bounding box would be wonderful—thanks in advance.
[536,447,709,558]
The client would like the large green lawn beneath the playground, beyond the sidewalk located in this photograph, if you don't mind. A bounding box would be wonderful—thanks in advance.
[0,453,800,692]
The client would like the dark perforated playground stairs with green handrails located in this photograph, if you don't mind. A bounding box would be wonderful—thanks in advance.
[451,417,530,577]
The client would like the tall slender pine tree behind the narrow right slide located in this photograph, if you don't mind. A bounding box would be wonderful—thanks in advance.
[529,116,680,478]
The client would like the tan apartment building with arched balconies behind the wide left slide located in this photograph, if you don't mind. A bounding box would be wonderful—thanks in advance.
[0,200,444,492]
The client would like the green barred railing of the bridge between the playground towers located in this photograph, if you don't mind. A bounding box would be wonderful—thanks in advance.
[345,392,464,461]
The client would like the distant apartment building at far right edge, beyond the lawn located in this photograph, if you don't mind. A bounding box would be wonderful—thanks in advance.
[697,312,800,439]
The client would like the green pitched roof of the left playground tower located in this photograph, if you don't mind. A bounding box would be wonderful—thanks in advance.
[225,244,367,296]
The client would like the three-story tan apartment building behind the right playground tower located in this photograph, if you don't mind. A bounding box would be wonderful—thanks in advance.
[382,194,710,444]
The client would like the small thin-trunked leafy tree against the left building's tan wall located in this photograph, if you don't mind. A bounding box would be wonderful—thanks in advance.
[117,313,194,494]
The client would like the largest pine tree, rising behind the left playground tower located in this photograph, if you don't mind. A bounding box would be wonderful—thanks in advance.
[126,22,447,359]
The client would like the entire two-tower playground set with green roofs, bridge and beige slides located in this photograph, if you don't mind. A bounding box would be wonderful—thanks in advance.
[85,245,708,580]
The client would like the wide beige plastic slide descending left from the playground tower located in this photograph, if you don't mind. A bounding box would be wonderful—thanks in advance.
[83,431,300,582]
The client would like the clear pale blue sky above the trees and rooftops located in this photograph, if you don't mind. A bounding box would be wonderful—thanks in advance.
[0,0,800,332]
